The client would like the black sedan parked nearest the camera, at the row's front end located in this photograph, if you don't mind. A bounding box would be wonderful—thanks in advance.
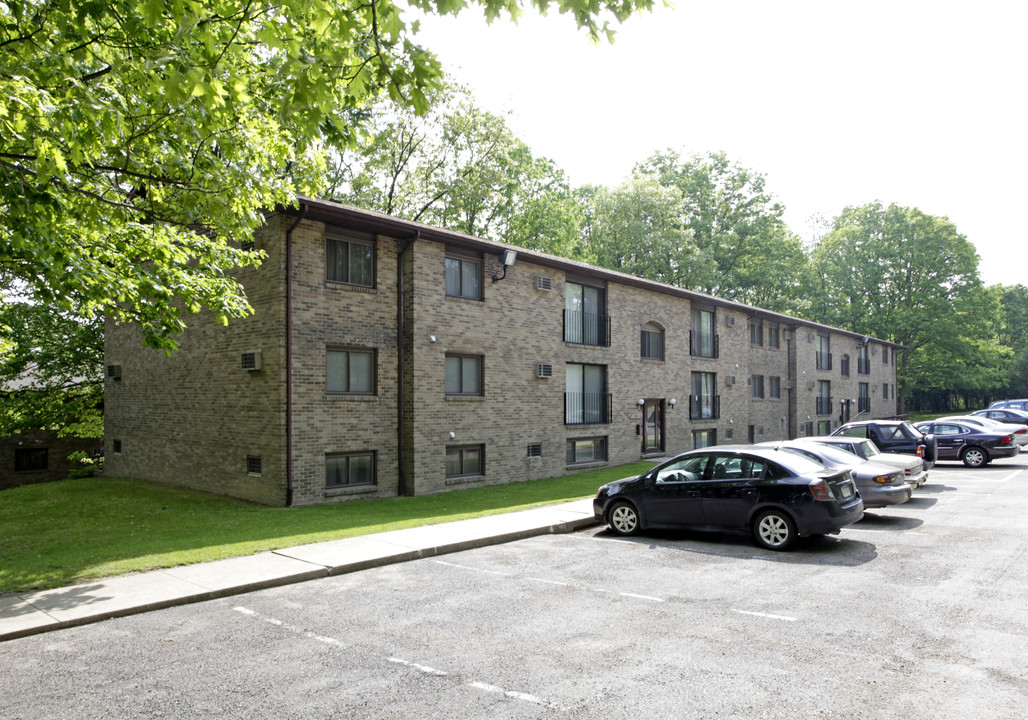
[592,445,864,550]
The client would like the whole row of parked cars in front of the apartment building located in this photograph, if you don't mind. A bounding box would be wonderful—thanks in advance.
[593,412,1028,550]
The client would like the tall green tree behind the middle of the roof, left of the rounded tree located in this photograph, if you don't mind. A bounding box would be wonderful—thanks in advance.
[635,150,807,312]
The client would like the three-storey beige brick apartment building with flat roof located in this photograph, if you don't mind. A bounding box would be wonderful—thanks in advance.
[105,199,898,505]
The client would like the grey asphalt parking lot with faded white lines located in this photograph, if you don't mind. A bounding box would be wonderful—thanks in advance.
[0,458,1028,720]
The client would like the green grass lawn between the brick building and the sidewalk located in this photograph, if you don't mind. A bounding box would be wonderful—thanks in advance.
[0,463,652,593]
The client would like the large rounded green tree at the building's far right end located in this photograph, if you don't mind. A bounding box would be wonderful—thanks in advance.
[812,203,1006,409]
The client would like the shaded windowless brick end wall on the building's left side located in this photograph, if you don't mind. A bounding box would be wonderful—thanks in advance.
[104,218,286,505]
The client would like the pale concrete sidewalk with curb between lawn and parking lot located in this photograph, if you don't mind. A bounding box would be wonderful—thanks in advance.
[0,499,596,641]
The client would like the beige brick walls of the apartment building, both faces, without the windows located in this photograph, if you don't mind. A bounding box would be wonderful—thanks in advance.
[106,202,895,505]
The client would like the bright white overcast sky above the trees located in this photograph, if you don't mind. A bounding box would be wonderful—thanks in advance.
[417,0,1028,285]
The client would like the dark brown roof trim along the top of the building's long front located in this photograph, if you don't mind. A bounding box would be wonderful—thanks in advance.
[277,195,906,349]
